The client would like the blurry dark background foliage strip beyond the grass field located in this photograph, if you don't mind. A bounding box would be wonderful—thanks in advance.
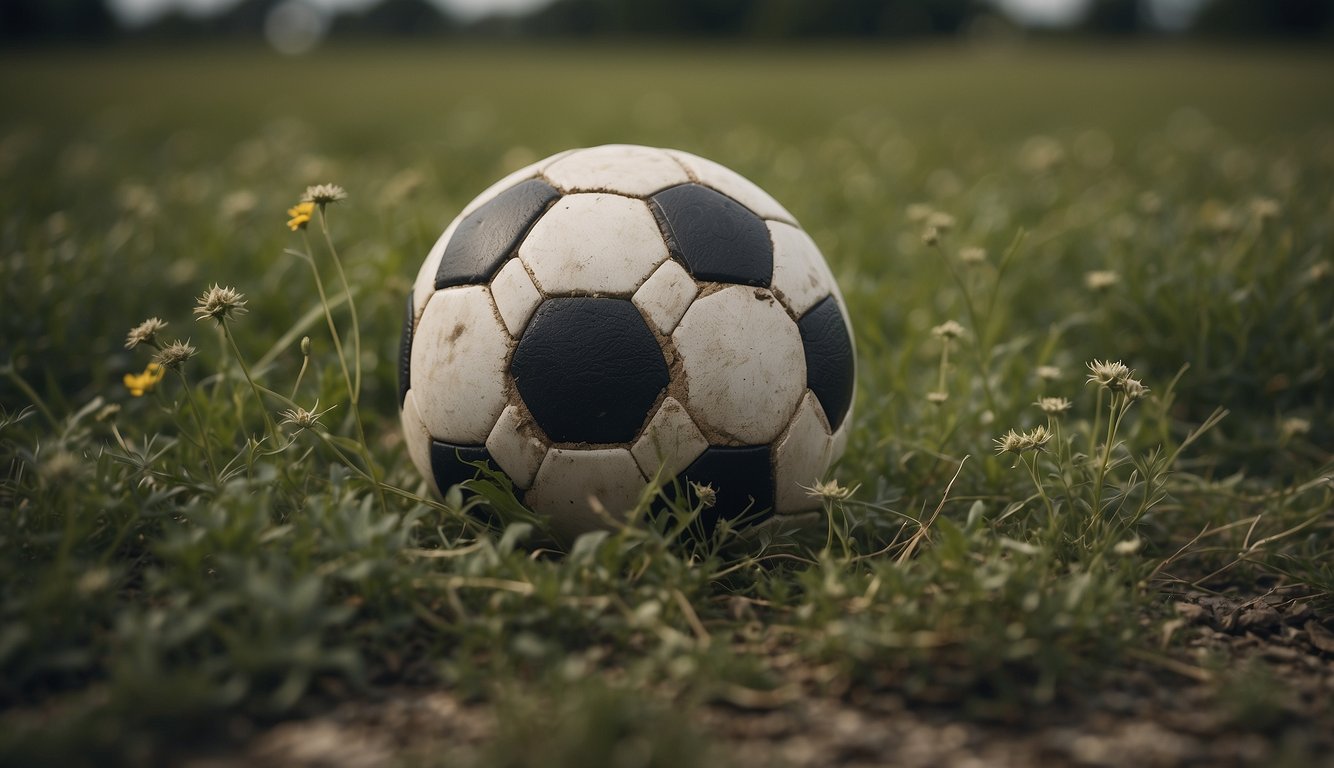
[0,0,1334,44]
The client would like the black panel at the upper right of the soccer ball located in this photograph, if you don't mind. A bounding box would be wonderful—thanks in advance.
[651,184,774,288]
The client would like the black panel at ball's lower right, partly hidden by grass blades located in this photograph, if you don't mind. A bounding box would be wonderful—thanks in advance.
[664,445,774,533]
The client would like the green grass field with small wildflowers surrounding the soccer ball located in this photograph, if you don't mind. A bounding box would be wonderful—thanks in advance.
[0,47,1334,767]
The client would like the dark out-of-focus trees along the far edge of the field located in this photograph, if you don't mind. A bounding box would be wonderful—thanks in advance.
[0,0,1334,43]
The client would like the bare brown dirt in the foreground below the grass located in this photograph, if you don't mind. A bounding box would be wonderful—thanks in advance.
[197,592,1334,768]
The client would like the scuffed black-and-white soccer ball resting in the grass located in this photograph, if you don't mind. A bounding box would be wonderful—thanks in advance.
[399,145,855,539]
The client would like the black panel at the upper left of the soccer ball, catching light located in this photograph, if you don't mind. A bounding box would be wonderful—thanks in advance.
[435,179,560,289]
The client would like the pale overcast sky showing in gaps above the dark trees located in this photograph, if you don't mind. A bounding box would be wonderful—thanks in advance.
[109,0,1202,25]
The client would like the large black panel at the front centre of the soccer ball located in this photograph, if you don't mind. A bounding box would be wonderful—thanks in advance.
[510,296,668,444]
